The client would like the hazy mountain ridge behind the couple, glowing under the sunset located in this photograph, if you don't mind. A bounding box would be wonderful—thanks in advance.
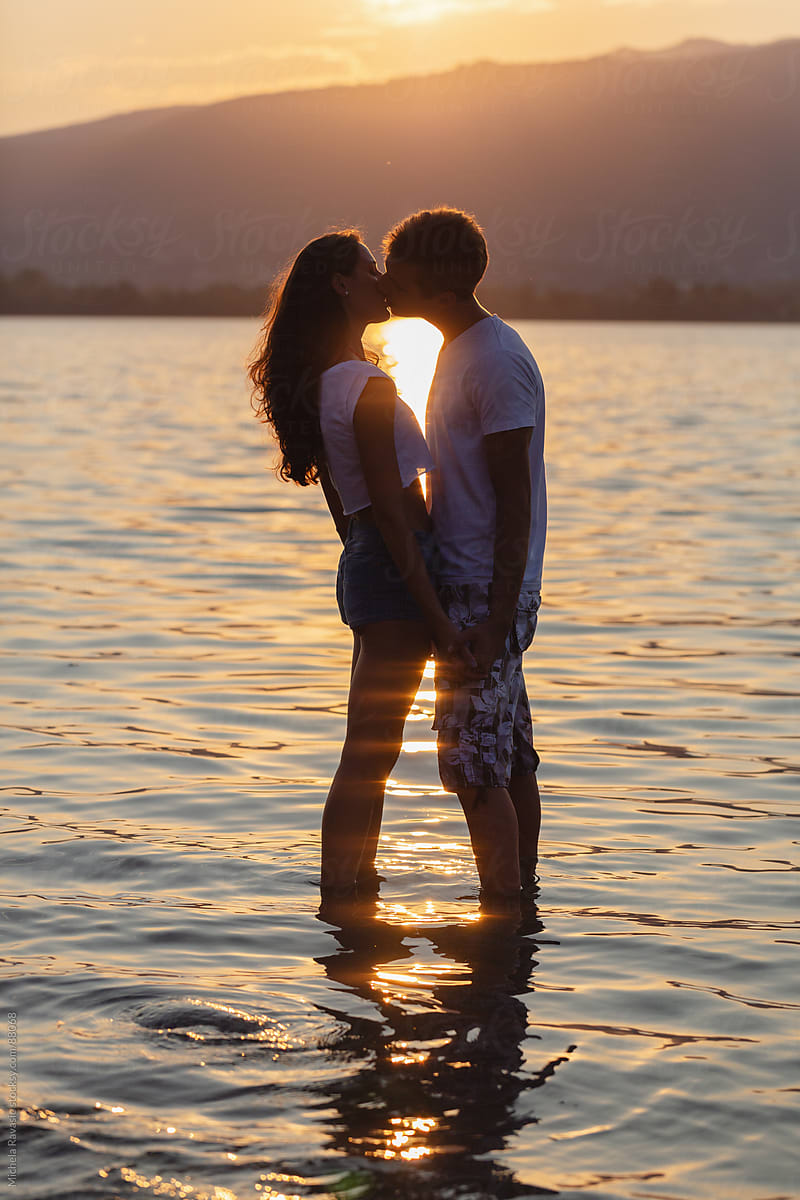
[0,38,800,288]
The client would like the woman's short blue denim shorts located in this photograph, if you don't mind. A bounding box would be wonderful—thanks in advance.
[336,521,439,629]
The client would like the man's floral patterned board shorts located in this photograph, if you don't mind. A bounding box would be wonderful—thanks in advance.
[433,583,541,792]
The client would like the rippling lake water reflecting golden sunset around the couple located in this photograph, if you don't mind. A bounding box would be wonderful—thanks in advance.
[0,318,800,1200]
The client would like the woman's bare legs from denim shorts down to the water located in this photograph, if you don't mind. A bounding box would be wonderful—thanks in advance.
[321,620,431,890]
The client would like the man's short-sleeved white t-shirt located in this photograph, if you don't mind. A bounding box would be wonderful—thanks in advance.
[426,316,547,589]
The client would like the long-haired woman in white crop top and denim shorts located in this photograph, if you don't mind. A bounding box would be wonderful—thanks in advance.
[249,230,467,895]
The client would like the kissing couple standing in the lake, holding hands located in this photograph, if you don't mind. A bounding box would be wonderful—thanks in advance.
[249,209,547,899]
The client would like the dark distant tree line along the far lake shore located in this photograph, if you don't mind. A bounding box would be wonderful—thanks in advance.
[0,268,800,322]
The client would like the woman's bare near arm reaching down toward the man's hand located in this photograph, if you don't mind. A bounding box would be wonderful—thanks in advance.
[353,379,456,654]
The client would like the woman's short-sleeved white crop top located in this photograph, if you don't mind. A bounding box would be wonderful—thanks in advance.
[319,359,433,515]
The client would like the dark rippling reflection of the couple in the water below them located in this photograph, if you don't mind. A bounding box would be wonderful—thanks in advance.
[309,900,575,1200]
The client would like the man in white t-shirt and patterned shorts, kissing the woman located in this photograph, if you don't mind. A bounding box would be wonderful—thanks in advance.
[383,209,547,896]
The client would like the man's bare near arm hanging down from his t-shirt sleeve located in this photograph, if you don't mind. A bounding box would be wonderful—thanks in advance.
[458,426,533,680]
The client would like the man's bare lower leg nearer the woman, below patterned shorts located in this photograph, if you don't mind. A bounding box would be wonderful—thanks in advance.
[458,787,519,896]
